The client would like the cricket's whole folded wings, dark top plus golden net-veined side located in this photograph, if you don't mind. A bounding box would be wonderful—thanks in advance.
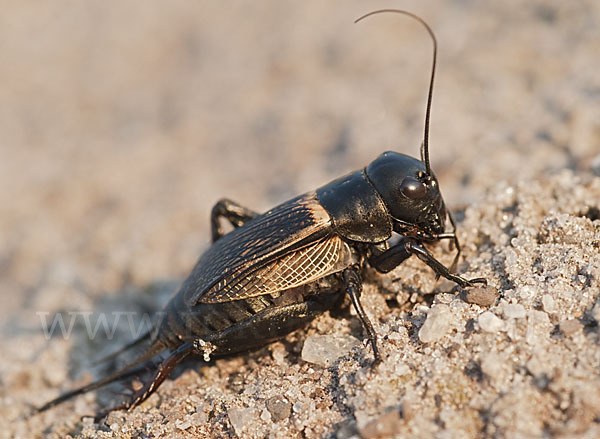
[181,192,342,306]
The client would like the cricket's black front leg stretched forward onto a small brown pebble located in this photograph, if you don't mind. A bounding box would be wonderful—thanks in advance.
[369,239,487,288]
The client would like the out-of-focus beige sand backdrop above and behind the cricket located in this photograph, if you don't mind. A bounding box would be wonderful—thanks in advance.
[0,0,600,432]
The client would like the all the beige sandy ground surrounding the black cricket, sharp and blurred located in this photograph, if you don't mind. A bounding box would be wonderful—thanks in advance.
[0,0,600,439]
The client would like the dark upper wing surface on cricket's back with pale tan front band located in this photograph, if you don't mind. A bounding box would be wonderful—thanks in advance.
[181,192,331,306]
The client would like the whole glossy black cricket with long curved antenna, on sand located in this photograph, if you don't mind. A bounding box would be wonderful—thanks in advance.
[38,10,485,418]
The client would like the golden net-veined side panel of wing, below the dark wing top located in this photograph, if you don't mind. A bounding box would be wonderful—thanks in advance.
[200,235,351,303]
